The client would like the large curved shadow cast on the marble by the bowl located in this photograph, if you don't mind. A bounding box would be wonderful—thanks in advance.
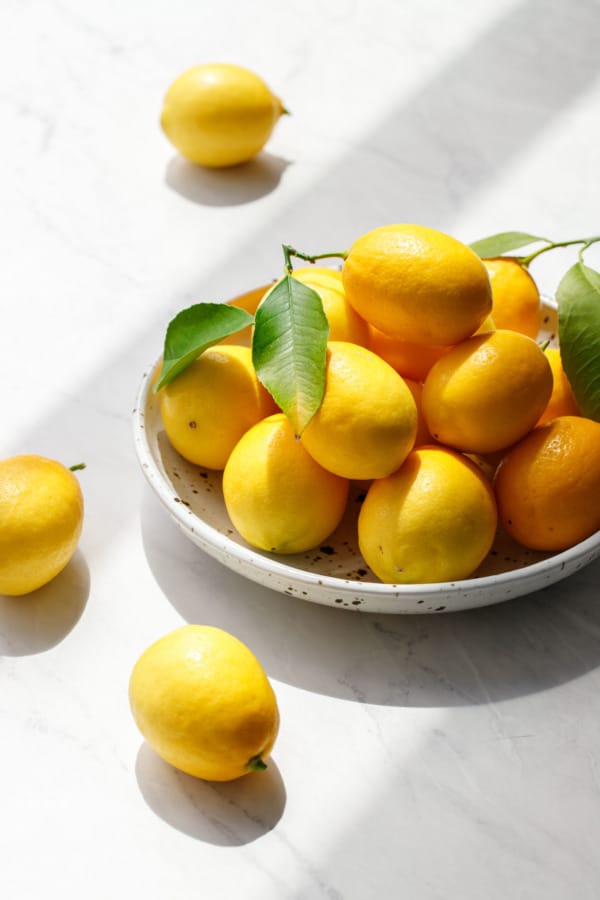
[142,488,600,707]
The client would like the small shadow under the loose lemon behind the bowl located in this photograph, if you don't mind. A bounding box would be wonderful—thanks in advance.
[165,151,289,206]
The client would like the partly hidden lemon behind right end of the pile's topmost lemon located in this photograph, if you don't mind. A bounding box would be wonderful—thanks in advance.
[483,256,542,338]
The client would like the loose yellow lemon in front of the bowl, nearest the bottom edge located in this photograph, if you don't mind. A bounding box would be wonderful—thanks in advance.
[129,625,279,781]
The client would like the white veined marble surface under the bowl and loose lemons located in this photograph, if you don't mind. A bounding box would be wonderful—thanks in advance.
[0,0,600,900]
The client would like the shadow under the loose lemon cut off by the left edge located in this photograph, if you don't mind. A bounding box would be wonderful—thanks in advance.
[0,550,90,656]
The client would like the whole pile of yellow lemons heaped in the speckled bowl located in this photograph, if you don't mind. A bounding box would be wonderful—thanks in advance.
[159,225,600,584]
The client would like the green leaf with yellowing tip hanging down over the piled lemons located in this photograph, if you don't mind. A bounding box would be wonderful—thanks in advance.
[252,275,329,435]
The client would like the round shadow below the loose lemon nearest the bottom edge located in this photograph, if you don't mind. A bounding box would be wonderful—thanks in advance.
[135,743,286,847]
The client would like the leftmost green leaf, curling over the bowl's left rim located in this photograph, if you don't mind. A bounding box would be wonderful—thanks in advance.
[154,303,254,392]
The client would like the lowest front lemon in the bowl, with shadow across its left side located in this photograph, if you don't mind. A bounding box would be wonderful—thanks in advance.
[358,447,497,584]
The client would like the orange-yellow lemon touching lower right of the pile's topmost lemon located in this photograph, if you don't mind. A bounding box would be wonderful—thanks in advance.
[422,329,552,453]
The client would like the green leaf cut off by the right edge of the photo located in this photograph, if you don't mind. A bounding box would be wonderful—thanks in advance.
[556,262,600,422]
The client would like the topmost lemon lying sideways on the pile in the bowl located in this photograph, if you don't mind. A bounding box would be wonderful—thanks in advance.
[342,225,492,346]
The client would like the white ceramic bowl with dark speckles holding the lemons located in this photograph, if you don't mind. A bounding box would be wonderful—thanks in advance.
[133,300,600,613]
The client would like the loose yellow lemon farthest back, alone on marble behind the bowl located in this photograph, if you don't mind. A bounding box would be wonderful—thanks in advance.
[160,63,285,168]
